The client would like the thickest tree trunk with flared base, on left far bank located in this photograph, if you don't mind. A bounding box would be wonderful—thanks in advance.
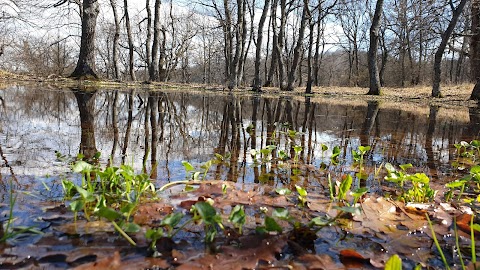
[70,0,99,79]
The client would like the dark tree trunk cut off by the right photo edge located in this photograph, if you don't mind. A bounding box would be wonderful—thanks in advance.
[470,0,480,101]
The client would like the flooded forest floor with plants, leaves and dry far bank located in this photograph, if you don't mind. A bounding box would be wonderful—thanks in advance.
[0,73,480,269]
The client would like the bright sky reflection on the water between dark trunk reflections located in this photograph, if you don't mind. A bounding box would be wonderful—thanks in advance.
[0,84,473,196]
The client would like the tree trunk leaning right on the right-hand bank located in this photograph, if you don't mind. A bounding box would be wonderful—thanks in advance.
[432,0,473,97]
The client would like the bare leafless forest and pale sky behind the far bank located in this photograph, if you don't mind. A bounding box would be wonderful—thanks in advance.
[0,0,478,93]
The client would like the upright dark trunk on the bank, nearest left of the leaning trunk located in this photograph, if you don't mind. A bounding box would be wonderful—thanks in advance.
[367,0,383,95]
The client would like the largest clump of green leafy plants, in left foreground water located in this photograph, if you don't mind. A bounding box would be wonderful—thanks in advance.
[62,161,156,245]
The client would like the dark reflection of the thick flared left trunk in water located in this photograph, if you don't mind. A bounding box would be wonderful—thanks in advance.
[73,89,97,160]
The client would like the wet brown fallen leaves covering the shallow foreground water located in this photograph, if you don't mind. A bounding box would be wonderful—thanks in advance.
[0,178,477,269]
